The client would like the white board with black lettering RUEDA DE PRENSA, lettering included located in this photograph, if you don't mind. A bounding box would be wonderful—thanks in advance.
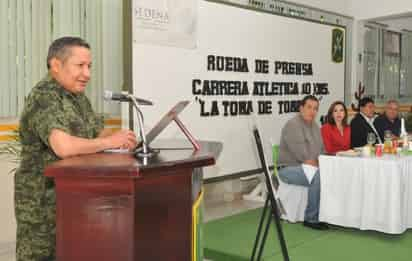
[134,0,345,178]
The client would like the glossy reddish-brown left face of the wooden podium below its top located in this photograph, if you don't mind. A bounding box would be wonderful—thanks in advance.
[56,178,135,261]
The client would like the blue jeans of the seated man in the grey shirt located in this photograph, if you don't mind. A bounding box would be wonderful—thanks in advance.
[279,166,320,223]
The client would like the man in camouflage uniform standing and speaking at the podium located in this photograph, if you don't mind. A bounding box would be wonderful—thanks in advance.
[15,37,136,261]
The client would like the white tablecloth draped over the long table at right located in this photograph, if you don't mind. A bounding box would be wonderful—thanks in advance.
[319,155,412,234]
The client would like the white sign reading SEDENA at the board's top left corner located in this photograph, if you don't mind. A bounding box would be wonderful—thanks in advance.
[132,0,197,48]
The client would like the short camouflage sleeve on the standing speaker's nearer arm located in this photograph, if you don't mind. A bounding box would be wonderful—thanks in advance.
[29,93,71,147]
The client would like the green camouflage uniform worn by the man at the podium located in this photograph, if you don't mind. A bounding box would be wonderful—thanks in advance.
[14,76,103,261]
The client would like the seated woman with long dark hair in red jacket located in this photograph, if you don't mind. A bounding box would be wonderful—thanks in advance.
[321,101,350,154]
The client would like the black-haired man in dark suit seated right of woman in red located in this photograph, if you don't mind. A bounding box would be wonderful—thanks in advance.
[350,97,382,148]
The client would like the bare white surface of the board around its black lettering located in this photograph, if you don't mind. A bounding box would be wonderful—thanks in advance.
[133,1,345,178]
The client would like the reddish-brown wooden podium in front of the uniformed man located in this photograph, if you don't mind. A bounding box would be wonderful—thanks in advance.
[45,143,221,261]
